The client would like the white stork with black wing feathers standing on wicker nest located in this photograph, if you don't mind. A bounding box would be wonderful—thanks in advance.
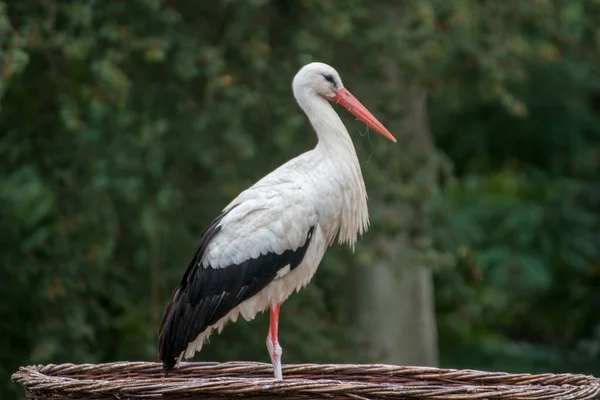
[158,62,396,379]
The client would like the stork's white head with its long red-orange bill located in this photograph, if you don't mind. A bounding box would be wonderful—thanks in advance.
[292,62,396,142]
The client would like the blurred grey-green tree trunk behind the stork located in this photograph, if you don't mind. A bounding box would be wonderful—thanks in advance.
[358,90,438,366]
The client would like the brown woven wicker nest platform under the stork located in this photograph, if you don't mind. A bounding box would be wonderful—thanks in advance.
[12,362,600,400]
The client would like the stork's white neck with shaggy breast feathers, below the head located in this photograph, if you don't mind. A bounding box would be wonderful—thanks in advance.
[294,91,369,248]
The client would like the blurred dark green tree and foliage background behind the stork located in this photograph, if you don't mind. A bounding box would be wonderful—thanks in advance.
[0,0,600,399]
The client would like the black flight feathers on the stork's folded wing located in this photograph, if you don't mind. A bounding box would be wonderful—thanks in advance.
[158,211,314,373]
